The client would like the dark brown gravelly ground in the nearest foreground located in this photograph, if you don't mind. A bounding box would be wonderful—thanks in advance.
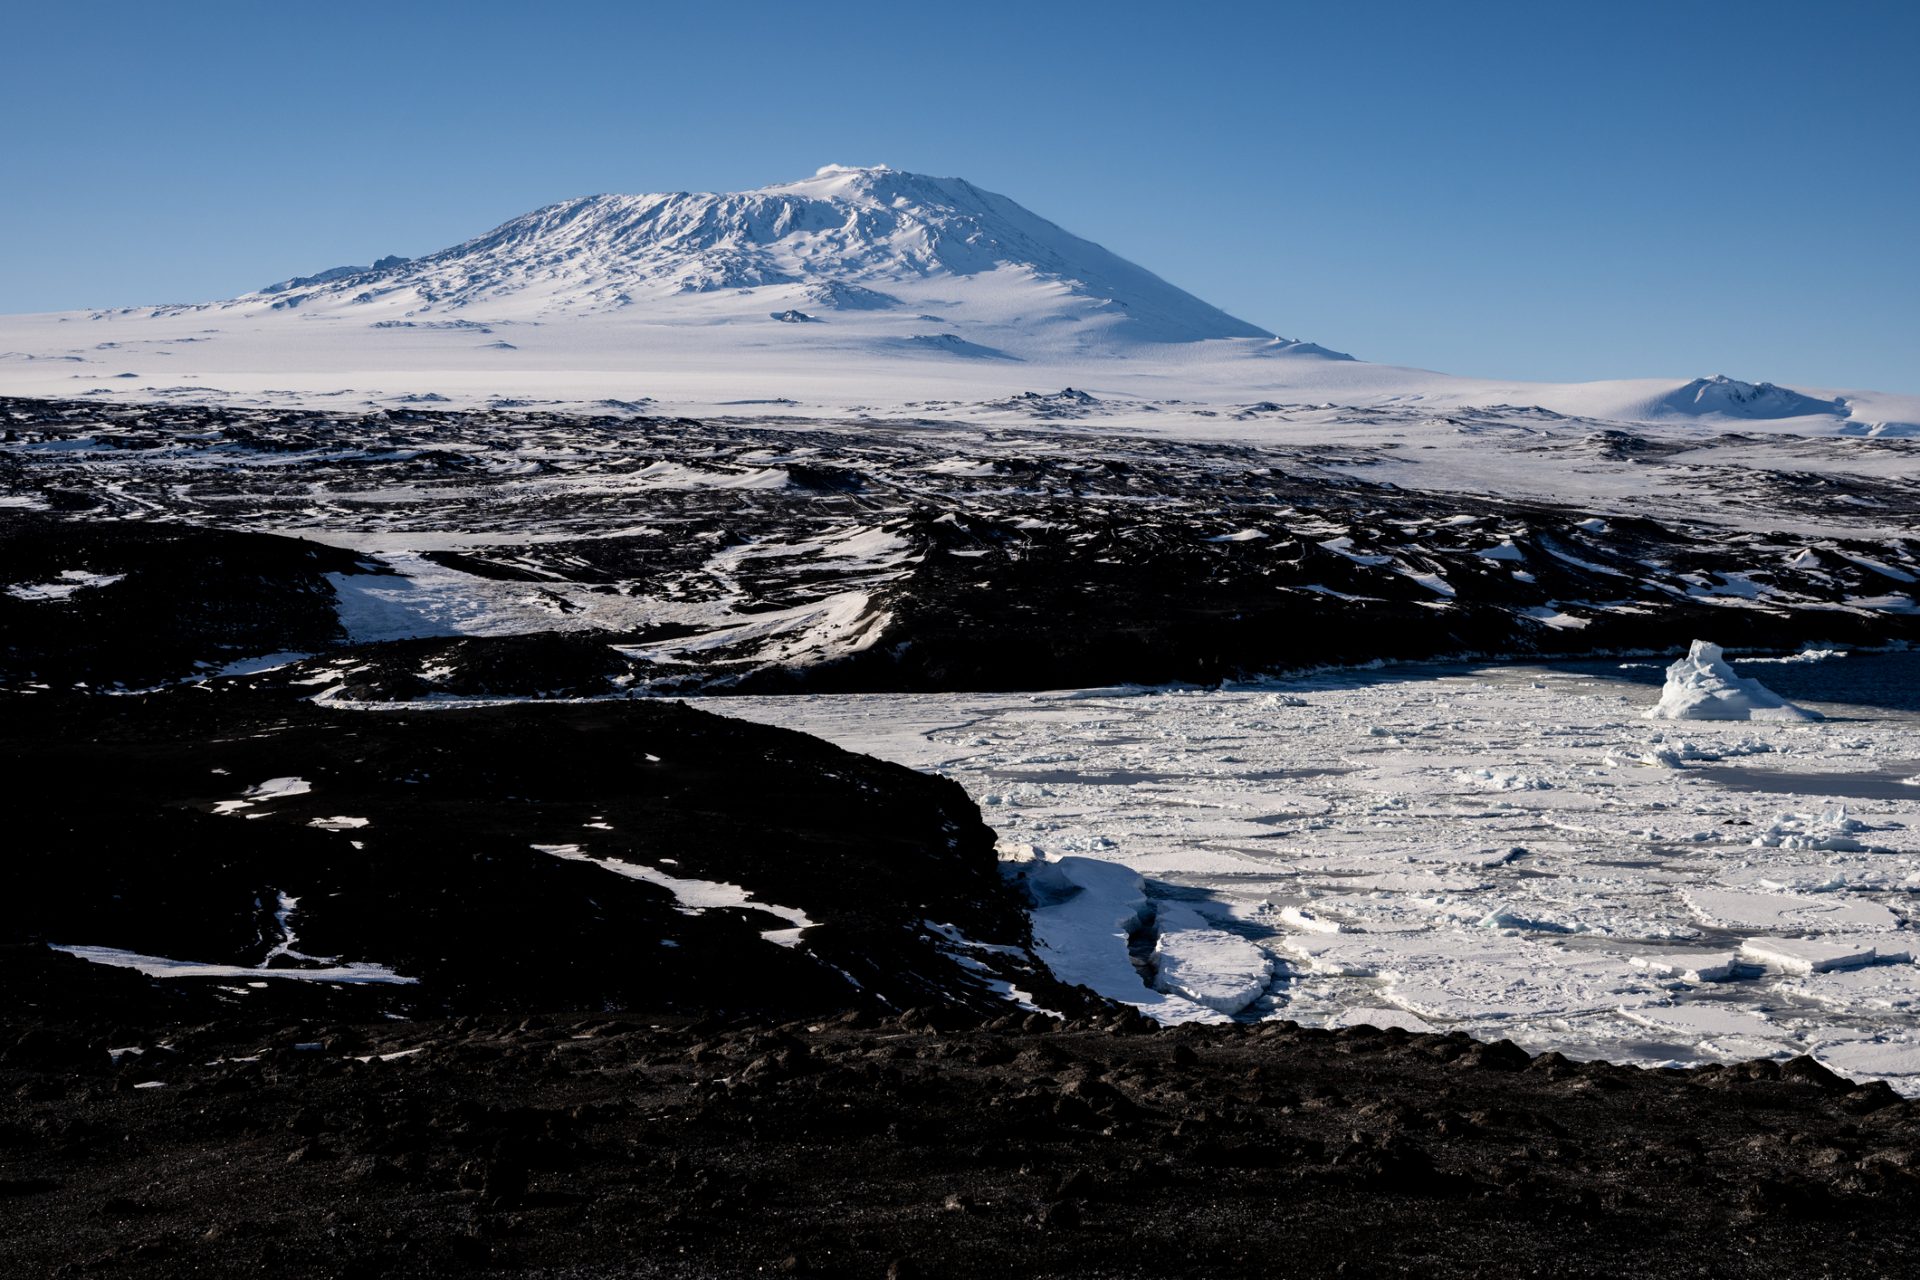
[0,948,1920,1276]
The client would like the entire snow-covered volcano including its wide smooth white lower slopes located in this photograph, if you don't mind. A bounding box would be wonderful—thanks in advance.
[0,165,1920,436]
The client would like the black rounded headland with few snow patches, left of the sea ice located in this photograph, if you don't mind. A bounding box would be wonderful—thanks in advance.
[0,689,1071,1015]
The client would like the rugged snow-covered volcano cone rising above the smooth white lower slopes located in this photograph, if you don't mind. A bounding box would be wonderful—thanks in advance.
[251,165,1271,355]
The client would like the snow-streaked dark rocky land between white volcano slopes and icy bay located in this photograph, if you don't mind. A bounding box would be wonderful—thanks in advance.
[0,401,1920,699]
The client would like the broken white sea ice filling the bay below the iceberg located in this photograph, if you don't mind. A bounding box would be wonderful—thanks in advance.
[718,668,1920,1094]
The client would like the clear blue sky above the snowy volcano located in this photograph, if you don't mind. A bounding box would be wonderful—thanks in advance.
[0,0,1920,391]
